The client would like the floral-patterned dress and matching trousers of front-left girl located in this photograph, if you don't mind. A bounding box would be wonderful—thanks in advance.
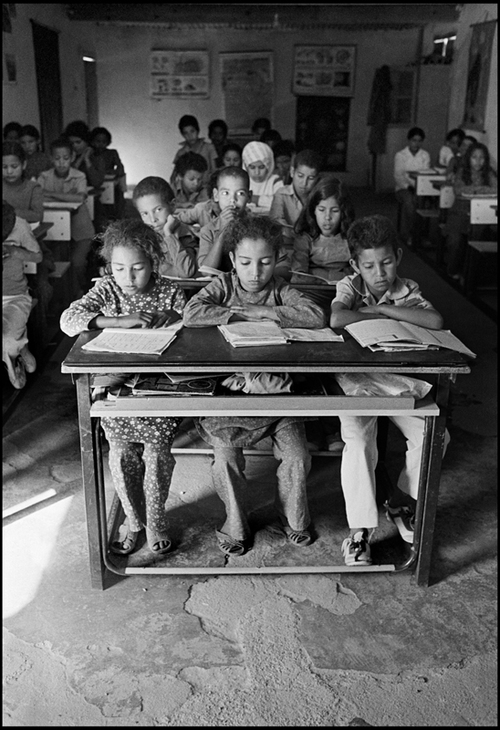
[61,274,186,535]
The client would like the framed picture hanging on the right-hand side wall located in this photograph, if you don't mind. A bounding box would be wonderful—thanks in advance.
[463,20,497,132]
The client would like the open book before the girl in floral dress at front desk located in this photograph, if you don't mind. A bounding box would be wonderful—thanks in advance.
[82,321,182,355]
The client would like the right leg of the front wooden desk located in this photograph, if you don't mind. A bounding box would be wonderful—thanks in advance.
[415,375,450,586]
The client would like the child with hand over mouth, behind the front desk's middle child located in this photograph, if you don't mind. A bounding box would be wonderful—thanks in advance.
[198,167,289,276]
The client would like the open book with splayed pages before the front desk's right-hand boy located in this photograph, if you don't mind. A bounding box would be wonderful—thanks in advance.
[344,319,476,357]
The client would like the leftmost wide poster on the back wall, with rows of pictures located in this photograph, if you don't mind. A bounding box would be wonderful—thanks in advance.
[150,50,210,99]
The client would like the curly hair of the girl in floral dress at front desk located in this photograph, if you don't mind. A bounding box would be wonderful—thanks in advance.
[97,218,163,271]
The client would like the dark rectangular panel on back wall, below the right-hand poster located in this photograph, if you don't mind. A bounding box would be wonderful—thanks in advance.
[295,96,351,172]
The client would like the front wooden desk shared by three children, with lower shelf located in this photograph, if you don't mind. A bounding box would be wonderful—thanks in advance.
[62,327,470,589]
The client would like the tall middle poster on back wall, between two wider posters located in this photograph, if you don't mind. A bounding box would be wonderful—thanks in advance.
[219,51,273,136]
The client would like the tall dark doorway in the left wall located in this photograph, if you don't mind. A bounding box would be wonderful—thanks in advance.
[31,20,63,151]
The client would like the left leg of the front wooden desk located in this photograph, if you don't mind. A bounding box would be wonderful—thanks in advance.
[76,374,106,590]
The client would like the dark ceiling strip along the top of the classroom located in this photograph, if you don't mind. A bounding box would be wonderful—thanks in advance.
[66,3,459,30]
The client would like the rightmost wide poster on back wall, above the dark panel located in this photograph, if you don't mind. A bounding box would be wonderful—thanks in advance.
[292,46,356,96]
